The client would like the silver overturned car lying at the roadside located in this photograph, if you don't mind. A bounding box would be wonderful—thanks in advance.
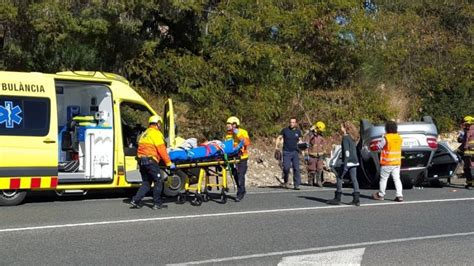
[328,116,460,188]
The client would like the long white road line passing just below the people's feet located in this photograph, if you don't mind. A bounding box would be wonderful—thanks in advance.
[0,198,474,233]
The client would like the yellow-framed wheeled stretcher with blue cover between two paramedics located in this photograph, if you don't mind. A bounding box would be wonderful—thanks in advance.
[169,140,243,206]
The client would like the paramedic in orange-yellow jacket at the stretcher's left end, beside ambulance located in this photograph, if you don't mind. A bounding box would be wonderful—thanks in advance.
[130,115,176,210]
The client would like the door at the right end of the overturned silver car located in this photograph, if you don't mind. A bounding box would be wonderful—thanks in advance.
[428,142,459,178]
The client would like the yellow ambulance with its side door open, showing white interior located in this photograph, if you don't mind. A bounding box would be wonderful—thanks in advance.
[0,71,175,206]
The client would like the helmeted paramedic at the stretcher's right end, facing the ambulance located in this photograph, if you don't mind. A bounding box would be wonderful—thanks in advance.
[225,116,250,202]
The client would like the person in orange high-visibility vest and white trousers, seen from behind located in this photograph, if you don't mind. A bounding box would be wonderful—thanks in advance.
[372,121,403,202]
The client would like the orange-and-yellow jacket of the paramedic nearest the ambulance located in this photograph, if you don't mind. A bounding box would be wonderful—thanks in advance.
[137,127,171,166]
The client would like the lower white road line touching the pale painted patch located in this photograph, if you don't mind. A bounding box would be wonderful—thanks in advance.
[168,232,474,265]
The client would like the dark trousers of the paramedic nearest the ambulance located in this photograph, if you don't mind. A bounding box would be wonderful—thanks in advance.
[132,162,163,204]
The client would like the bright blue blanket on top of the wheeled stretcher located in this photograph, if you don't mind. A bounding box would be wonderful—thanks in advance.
[169,140,244,162]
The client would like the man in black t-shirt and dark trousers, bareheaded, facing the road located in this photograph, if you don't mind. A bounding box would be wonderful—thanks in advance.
[275,117,303,190]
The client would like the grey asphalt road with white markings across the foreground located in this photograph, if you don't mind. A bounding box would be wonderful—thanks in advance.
[0,187,474,265]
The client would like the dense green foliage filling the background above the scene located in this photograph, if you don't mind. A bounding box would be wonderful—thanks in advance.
[0,0,474,136]
